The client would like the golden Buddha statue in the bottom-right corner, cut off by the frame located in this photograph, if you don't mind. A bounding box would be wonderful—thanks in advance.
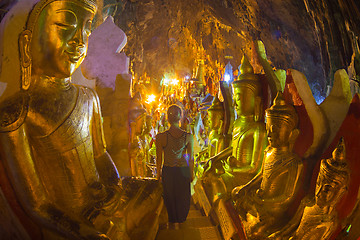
[269,138,350,240]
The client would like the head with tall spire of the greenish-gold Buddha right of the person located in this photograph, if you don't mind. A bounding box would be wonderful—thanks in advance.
[232,56,261,121]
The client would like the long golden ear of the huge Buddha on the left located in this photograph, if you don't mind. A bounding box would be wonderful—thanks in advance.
[19,30,32,90]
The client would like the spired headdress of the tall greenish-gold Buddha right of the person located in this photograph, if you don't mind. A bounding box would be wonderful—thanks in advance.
[232,55,261,95]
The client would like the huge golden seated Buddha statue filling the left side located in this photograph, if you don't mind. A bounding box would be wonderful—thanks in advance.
[0,0,161,239]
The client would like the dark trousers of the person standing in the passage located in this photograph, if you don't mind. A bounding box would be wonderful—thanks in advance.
[162,166,191,223]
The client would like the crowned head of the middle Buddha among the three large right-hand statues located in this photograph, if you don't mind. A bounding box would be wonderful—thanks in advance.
[265,92,299,150]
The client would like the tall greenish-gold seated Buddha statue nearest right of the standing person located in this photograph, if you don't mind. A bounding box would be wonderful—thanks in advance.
[205,56,266,193]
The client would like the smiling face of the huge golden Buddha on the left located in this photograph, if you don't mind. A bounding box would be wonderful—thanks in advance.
[20,0,95,78]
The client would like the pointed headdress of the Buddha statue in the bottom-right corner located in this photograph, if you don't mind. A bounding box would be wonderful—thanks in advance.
[319,138,350,186]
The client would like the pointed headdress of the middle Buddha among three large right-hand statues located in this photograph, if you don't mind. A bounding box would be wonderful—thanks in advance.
[265,92,298,128]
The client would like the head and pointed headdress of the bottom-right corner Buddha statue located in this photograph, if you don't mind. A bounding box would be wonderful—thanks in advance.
[315,138,350,207]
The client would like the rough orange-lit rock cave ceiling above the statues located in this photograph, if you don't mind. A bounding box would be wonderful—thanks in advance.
[115,0,360,102]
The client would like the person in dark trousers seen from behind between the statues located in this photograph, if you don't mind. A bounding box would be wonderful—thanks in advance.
[156,105,194,228]
